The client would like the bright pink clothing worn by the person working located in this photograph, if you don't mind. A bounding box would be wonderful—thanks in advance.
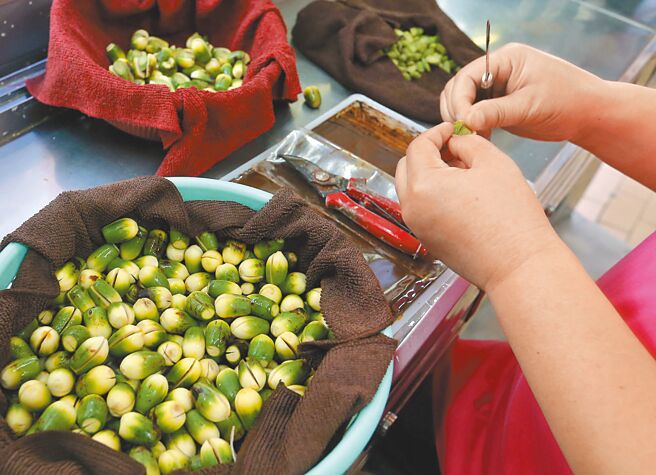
[435,233,656,475]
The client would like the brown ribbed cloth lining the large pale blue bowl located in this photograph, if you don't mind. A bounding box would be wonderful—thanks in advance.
[0,177,396,475]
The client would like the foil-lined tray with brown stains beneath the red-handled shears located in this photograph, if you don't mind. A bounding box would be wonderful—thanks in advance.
[226,96,451,339]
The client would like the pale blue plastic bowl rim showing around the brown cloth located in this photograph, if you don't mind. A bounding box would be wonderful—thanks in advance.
[0,178,392,475]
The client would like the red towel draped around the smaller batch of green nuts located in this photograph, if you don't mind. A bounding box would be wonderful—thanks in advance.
[27,0,301,176]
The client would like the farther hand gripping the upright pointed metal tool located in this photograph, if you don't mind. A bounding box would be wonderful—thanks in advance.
[440,43,605,141]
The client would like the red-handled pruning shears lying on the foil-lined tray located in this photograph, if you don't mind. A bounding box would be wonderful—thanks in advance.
[278,154,428,256]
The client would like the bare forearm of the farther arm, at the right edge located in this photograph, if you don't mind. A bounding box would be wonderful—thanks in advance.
[573,81,656,190]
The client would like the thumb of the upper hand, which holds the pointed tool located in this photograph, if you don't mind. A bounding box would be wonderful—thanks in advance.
[464,92,530,131]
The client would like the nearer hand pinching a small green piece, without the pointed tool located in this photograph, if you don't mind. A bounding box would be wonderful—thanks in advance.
[396,122,559,290]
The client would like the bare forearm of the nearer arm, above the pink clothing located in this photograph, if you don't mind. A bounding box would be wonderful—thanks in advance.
[488,242,656,474]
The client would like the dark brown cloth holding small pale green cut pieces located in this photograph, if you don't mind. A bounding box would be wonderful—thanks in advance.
[292,0,483,123]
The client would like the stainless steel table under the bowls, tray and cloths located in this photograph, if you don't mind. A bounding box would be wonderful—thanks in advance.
[0,0,656,468]
